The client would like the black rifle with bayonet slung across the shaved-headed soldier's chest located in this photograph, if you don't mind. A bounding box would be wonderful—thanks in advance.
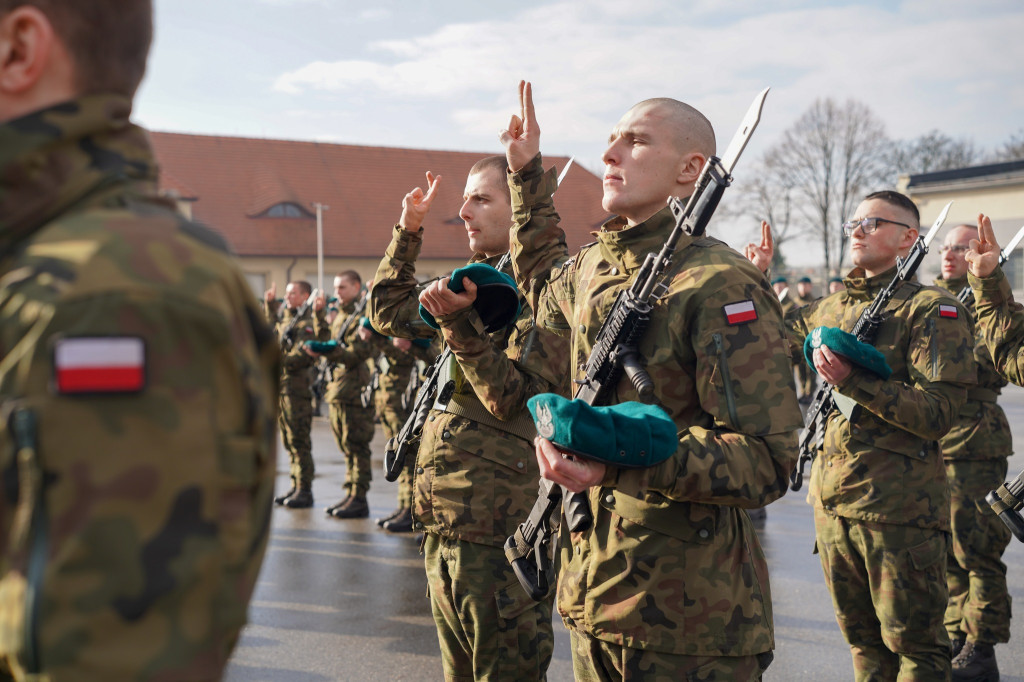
[505,88,768,600]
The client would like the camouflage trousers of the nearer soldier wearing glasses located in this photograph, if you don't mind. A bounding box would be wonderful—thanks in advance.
[814,508,952,682]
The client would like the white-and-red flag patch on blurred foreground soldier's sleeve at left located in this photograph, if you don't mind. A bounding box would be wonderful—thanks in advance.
[53,336,145,395]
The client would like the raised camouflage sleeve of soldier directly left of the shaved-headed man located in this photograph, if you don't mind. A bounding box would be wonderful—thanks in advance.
[367,225,437,339]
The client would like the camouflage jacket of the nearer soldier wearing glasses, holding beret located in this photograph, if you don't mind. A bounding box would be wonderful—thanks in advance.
[786,268,976,530]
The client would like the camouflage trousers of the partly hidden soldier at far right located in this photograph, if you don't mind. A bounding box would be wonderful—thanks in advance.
[945,458,1011,644]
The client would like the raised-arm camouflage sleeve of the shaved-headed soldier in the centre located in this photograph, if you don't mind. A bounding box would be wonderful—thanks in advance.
[508,154,568,310]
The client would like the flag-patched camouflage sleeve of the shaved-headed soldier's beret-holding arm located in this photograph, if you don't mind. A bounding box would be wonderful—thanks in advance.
[616,266,802,508]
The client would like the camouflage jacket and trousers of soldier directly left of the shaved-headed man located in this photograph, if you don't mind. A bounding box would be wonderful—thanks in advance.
[370,226,559,680]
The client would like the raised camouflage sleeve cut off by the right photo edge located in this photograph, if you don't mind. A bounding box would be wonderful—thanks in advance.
[968,268,1024,386]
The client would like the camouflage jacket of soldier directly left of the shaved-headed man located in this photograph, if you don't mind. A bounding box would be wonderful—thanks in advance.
[370,226,560,547]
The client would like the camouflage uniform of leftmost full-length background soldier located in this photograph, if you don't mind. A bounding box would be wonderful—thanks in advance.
[263,300,324,491]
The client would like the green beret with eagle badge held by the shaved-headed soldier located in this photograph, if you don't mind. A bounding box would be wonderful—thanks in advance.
[526,393,679,468]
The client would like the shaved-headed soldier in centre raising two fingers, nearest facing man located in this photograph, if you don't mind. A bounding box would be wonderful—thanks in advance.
[502,84,801,680]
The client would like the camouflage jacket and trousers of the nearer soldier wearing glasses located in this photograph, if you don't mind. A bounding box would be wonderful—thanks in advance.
[786,268,975,680]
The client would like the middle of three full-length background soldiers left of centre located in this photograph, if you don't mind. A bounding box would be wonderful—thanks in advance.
[306,270,378,518]
